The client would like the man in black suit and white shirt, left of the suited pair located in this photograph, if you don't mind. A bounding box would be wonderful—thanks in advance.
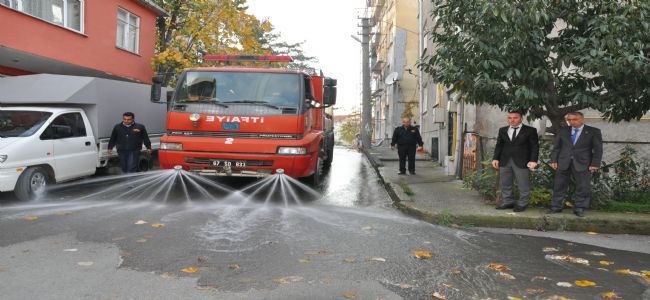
[492,112,539,212]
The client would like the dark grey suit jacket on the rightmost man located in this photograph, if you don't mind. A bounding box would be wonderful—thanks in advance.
[551,125,603,172]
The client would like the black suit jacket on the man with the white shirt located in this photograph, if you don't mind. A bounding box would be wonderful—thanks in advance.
[493,124,539,168]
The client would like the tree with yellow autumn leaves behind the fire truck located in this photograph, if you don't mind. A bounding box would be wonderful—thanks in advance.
[152,0,271,85]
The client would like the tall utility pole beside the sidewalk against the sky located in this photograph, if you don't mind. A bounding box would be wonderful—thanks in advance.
[361,17,372,149]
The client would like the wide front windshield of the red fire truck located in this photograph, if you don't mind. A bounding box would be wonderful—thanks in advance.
[175,71,302,109]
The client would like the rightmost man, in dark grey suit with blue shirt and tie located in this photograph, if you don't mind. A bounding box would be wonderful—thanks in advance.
[549,112,603,217]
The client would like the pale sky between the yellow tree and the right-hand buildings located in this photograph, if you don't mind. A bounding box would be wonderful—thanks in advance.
[247,0,365,114]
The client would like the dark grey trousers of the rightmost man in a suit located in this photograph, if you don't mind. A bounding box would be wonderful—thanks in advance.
[551,162,591,209]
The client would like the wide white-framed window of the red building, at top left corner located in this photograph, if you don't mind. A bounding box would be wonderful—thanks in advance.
[0,0,84,32]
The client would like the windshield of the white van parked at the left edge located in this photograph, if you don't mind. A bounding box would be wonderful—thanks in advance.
[0,110,52,138]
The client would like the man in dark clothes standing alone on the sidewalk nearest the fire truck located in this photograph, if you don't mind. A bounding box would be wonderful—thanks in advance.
[390,118,424,175]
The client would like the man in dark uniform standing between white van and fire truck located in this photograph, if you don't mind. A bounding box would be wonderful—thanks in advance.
[108,112,151,173]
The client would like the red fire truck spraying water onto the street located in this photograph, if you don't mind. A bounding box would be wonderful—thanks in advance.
[151,55,336,186]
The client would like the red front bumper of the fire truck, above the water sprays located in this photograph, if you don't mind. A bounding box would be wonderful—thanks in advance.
[158,150,318,177]
